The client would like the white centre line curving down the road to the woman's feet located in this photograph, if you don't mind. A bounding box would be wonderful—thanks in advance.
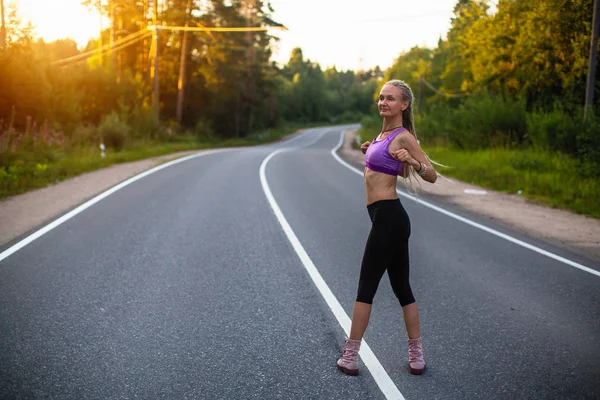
[259,135,404,400]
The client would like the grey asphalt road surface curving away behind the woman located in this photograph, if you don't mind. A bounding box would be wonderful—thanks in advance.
[0,127,600,400]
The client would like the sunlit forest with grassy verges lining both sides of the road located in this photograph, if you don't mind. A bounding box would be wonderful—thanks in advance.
[0,0,600,217]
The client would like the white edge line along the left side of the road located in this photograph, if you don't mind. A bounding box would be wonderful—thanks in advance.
[0,149,232,262]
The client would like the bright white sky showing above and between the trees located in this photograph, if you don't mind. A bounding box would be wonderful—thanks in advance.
[14,0,464,70]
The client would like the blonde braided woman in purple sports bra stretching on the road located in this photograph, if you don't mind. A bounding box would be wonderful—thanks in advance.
[337,80,437,375]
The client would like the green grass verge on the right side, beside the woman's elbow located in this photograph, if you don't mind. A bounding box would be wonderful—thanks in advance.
[425,147,600,218]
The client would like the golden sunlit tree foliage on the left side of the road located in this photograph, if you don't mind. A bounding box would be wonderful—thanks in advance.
[0,0,382,145]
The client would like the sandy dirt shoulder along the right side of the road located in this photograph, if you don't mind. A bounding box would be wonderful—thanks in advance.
[340,131,600,261]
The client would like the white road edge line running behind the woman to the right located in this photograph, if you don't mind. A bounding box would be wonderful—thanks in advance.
[331,131,600,276]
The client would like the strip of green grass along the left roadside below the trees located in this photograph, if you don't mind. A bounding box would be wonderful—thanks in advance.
[0,124,314,199]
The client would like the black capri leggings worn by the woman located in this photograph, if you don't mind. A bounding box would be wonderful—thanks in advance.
[356,199,415,307]
